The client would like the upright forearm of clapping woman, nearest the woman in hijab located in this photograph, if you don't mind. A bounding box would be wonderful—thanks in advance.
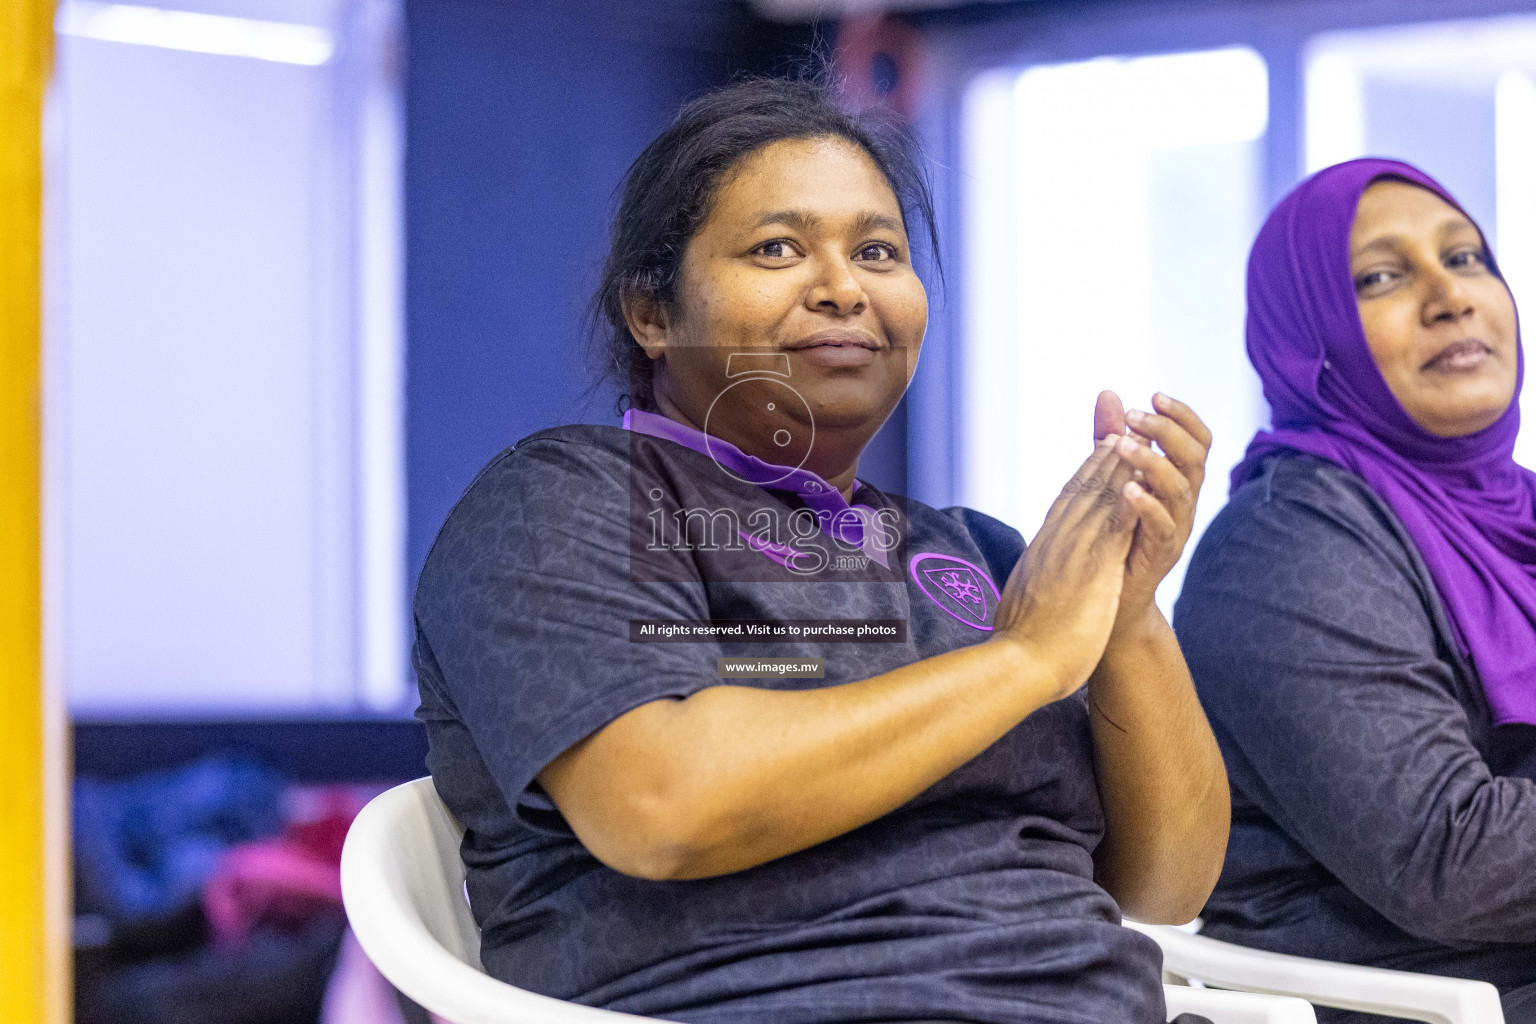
[1087,606,1230,923]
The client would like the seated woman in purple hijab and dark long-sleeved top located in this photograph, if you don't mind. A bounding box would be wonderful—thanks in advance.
[1175,160,1536,1022]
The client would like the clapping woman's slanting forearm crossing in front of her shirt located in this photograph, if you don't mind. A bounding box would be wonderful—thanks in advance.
[539,636,1081,880]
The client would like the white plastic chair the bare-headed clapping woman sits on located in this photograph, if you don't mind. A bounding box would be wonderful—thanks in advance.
[341,778,1316,1024]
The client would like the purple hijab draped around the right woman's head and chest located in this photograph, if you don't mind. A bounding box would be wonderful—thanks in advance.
[1232,160,1536,725]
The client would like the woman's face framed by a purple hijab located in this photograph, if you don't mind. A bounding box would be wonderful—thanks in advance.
[1350,181,1518,438]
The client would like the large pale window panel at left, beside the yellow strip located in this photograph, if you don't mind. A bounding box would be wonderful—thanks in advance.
[45,0,409,718]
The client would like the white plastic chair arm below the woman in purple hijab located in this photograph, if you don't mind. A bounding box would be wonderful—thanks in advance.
[1126,920,1504,1024]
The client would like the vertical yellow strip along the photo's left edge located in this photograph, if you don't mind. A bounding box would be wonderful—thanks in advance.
[0,0,69,1024]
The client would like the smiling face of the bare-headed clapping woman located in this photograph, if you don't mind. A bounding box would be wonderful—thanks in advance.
[628,138,928,471]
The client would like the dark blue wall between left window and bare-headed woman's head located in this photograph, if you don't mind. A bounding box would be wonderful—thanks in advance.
[406,0,809,588]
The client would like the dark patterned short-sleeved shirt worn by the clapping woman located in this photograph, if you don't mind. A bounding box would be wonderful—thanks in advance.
[415,427,1163,1024]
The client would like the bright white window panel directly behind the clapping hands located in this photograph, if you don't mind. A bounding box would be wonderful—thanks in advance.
[960,48,1269,608]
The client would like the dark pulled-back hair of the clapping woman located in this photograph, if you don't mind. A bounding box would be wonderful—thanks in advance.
[591,77,942,411]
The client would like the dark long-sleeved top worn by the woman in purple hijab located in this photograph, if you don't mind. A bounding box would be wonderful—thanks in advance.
[1174,454,1536,981]
